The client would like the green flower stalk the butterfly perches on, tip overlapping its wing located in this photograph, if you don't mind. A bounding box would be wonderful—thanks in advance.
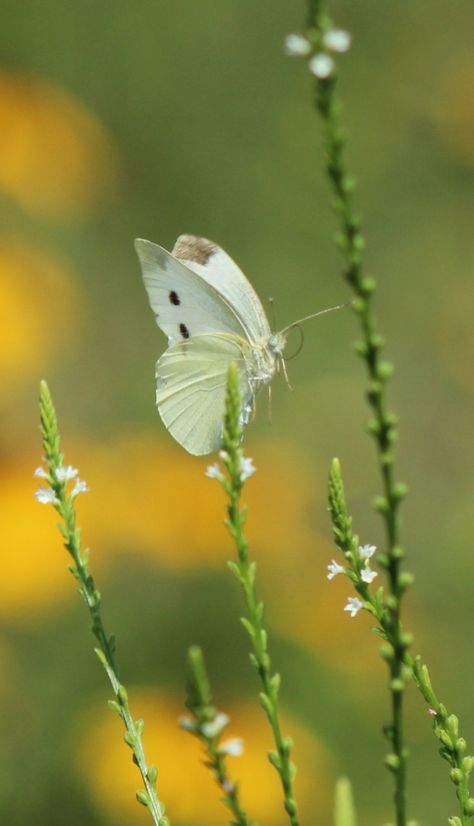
[209,365,299,826]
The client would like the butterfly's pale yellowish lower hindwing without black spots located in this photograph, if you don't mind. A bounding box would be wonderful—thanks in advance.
[156,334,253,456]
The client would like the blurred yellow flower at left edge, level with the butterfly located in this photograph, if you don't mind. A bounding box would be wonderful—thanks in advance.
[0,239,81,388]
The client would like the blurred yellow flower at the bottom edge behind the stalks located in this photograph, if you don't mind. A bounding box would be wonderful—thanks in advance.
[73,689,332,826]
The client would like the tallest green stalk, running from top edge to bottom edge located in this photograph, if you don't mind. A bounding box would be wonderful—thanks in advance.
[308,8,408,826]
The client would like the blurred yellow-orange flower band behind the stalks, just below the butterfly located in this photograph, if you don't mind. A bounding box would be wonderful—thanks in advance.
[0,436,324,614]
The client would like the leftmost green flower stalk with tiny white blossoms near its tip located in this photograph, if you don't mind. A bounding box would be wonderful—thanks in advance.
[38,381,169,826]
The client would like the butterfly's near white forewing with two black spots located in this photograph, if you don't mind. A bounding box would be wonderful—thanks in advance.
[135,239,246,344]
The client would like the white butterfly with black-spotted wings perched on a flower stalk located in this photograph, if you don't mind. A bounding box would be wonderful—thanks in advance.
[135,235,338,456]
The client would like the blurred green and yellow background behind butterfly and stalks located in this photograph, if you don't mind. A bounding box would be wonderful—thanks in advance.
[0,0,474,826]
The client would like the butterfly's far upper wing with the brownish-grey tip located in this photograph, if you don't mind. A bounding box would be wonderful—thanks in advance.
[172,235,271,342]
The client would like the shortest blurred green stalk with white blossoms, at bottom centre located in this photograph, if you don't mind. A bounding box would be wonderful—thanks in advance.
[181,646,256,826]
